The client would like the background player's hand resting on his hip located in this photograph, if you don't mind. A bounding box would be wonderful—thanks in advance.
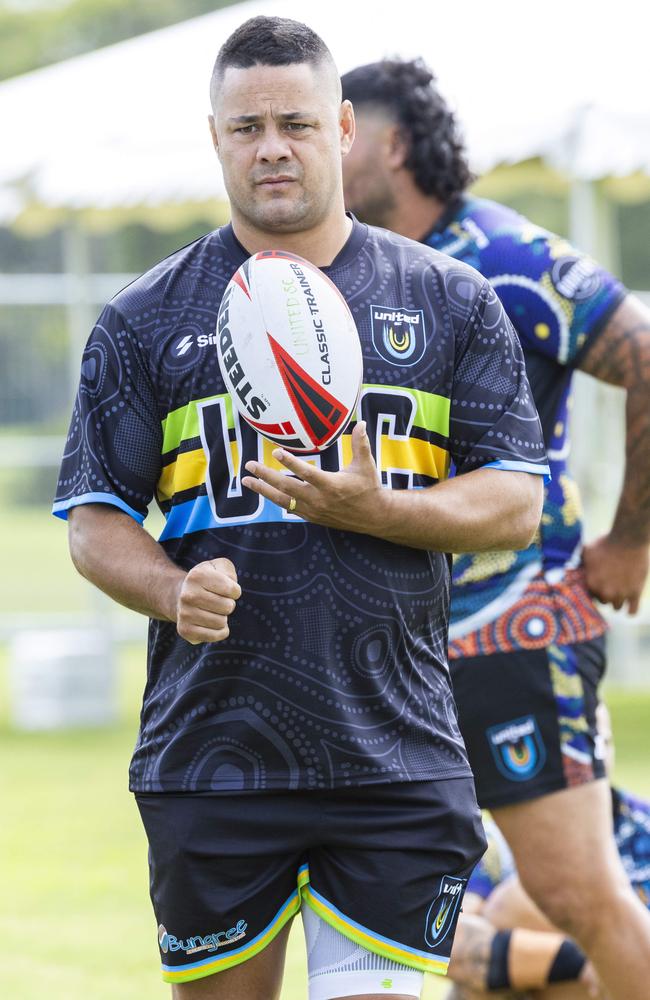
[582,535,650,615]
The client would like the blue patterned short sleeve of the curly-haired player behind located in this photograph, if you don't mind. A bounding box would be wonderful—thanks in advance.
[485,229,626,367]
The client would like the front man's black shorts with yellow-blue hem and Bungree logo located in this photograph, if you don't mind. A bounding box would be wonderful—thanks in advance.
[136,778,485,983]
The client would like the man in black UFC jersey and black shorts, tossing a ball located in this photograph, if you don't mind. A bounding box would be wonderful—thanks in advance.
[54,18,547,1000]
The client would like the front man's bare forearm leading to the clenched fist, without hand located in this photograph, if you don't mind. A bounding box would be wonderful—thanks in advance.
[68,504,186,622]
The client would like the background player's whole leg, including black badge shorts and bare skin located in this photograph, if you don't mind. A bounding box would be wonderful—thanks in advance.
[452,641,650,1000]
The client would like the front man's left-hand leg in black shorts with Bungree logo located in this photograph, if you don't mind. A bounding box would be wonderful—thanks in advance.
[137,793,308,1000]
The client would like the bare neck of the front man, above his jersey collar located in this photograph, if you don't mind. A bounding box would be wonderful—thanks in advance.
[232,212,352,267]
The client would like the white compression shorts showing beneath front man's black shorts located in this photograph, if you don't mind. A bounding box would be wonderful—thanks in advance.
[301,906,424,1000]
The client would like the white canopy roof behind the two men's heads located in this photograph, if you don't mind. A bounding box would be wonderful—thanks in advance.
[0,0,650,219]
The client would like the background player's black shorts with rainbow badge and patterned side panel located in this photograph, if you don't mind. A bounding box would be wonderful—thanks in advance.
[449,636,605,809]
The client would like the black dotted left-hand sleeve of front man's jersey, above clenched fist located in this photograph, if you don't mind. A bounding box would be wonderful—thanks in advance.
[52,306,162,522]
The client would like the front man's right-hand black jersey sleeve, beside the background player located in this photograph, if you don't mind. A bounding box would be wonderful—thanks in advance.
[449,282,549,475]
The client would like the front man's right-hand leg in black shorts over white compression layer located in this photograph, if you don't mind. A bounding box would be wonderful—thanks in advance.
[302,778,485,1000]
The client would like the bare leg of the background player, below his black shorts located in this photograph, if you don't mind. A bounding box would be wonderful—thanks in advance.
[493,779,650,1000]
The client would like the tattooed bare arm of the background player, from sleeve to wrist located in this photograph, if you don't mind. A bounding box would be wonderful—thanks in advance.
[580,295,650,545]
